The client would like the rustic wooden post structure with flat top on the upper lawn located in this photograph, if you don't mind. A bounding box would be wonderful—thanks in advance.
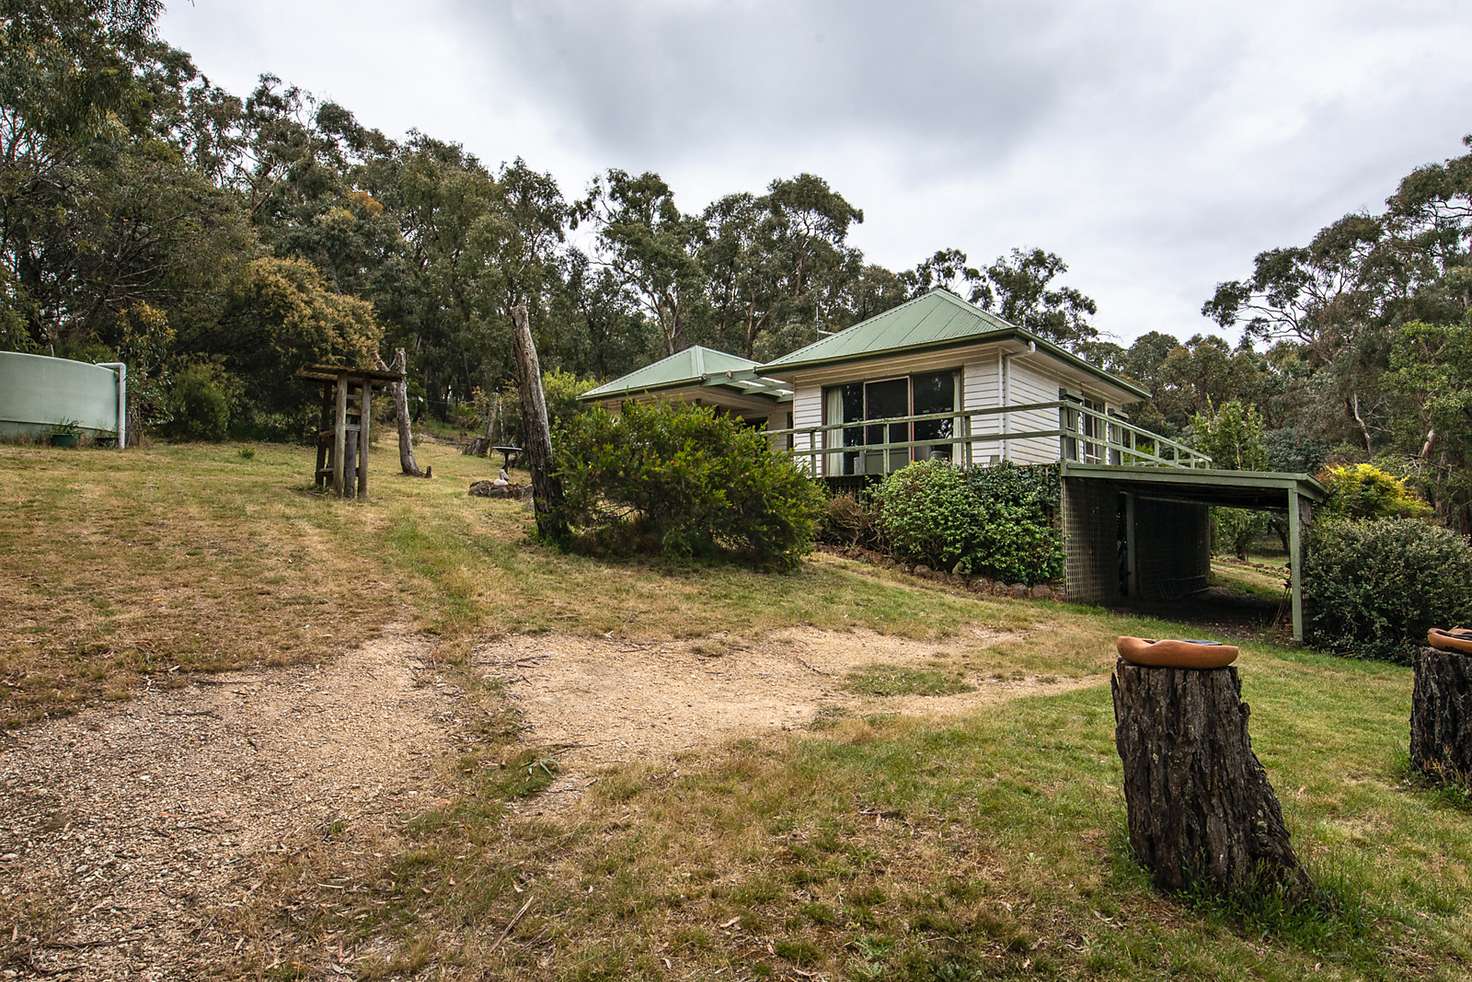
[297,365,403,499]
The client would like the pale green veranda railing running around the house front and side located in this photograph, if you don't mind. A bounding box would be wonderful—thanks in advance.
[767,399,1211,473]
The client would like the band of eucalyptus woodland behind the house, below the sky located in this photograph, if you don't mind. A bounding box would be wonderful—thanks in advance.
[0,0,1472,531]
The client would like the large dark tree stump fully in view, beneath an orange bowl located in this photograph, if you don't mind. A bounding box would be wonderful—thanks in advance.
[1111,660,1309,895]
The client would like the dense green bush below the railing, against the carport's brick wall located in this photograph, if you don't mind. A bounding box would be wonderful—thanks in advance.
[874,461,1063,583]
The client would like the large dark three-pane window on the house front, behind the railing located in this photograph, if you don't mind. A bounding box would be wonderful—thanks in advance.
[823,371,958,474]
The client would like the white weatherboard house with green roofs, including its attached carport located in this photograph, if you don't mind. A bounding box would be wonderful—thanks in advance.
[581,290,1323,637]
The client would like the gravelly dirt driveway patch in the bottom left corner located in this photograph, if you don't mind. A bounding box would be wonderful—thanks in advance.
[0,630,456,979]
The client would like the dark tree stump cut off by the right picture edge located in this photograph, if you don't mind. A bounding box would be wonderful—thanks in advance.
[1410,648,1472,788]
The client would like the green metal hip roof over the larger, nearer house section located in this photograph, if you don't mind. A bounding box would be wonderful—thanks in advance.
[757,287,1150,399]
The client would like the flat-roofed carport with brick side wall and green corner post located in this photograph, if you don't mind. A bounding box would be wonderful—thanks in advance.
[1063,462,1325,640]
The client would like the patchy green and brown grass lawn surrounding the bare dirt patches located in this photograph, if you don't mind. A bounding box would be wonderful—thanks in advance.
[0,445,1472,979]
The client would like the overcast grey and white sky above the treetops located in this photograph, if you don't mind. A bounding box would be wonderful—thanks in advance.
[162,0,1472,342]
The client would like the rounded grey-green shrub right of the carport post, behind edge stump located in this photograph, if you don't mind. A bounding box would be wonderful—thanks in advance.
[1303,518,1472,661]
